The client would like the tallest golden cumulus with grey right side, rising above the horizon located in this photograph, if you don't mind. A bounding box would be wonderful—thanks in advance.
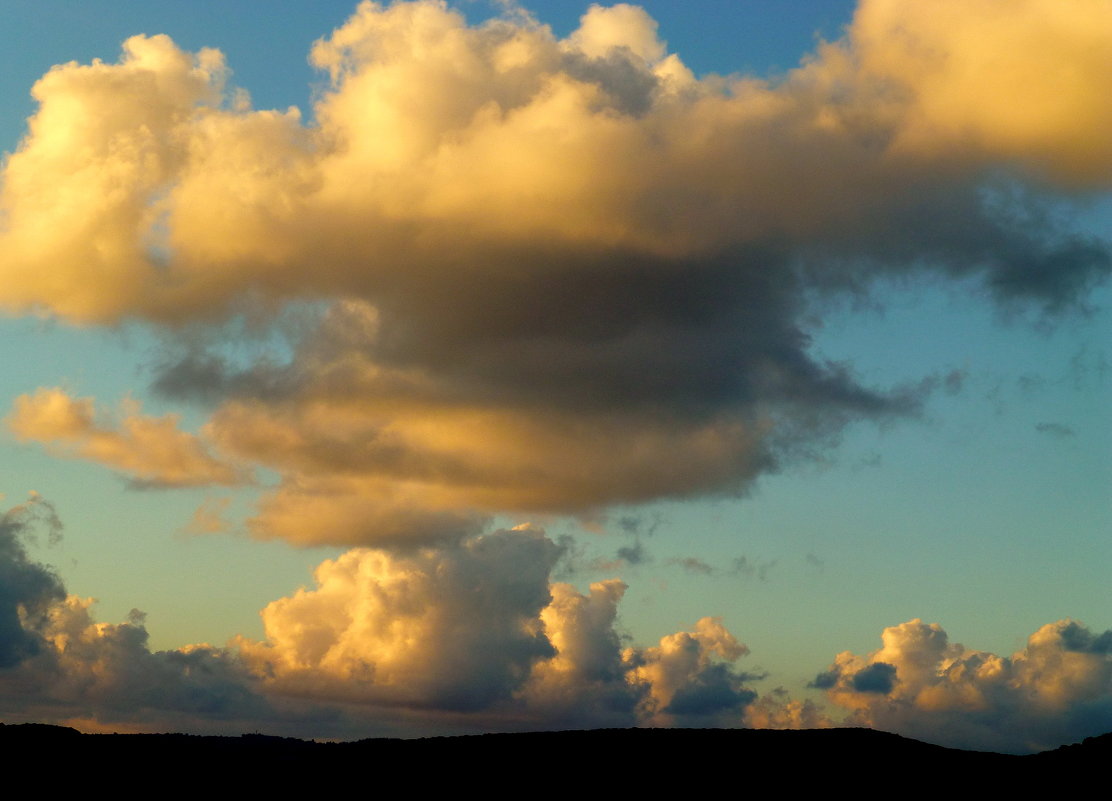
[239,531,558,710]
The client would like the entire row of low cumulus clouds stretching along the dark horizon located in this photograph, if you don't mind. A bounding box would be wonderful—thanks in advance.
[8,496,1112,752]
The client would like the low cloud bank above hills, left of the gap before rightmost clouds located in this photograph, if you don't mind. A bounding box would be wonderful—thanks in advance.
[0,496,755,736]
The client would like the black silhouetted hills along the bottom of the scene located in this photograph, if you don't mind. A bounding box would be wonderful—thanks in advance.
[0,723,1112,797]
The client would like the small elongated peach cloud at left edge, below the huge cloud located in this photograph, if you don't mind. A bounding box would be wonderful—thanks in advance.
[6,388,249,487]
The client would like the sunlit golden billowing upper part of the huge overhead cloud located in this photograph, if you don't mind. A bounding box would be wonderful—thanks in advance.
[2,0,1112,322]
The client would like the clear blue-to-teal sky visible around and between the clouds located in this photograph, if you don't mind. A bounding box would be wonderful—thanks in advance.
[0,0,1112,712]
